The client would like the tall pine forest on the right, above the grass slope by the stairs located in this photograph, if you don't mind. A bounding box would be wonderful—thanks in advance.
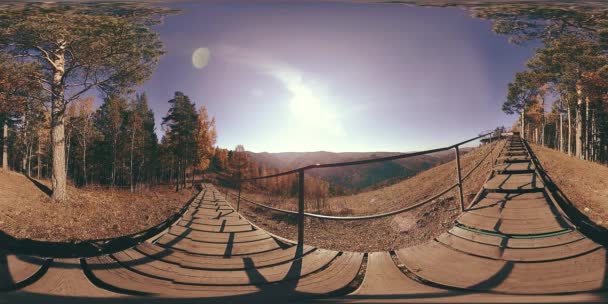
[473,4,608,164]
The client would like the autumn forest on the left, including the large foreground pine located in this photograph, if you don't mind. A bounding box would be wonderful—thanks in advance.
[0,3,328,201]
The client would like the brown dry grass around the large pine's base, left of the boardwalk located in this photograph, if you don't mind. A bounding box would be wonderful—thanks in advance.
[0,170,193,241]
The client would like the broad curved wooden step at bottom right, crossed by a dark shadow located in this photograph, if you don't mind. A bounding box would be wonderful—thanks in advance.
[397,242,606,294]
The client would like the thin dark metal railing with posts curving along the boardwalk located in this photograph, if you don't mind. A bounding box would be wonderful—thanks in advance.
[226,131,501,244]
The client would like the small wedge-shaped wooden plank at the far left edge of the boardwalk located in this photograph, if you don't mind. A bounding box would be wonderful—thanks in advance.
[0,251,45,290]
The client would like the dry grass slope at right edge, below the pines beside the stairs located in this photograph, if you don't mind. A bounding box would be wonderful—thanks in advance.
[531,144,608,228]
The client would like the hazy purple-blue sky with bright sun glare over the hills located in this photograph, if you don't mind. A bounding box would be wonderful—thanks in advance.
[142,1,532,152]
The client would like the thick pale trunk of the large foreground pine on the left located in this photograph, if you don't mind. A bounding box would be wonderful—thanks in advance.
[51,43,68,202]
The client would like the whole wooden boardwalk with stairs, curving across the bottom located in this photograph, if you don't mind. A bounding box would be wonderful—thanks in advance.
[0,137,608,303]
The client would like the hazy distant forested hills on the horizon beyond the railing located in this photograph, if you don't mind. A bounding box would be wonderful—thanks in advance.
[248,149,470,191]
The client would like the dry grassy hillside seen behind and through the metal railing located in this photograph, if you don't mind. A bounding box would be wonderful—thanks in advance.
[229,142,503,252]
